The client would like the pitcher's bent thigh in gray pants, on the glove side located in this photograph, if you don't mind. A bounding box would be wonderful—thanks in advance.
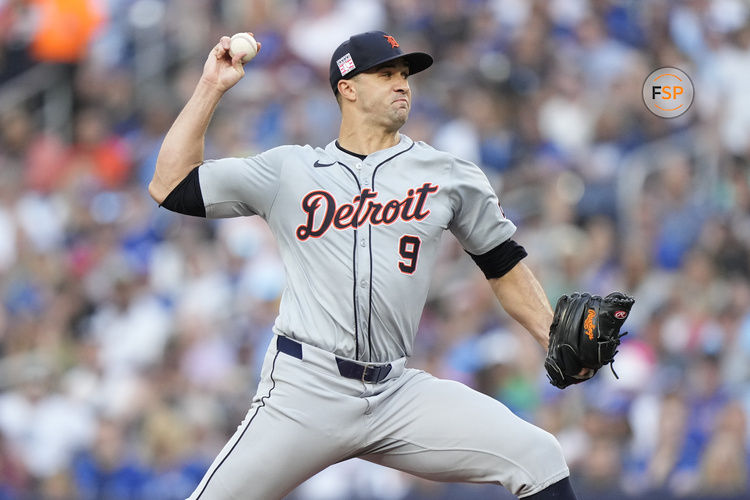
[362,372,569,496]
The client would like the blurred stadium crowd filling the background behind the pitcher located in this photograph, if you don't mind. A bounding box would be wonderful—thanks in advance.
[0,0,750,500]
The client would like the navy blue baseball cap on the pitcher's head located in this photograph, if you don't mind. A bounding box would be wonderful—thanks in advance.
[330,31,432,94]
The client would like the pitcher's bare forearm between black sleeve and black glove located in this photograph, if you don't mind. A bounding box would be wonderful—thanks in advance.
[490,262,554,350]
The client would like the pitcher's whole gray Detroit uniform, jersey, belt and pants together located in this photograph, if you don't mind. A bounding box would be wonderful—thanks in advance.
[190,136,569,500]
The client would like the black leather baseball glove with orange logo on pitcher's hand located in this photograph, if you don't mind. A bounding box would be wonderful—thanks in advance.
[544,292,635,389]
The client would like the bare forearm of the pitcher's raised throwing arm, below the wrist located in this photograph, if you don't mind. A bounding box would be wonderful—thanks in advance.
[149,79,223,203]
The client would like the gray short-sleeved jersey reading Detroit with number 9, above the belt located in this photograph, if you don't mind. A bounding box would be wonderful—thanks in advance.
[199,135,516,362]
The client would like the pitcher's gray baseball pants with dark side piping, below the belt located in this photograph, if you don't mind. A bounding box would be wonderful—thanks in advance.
[190,337,569,500]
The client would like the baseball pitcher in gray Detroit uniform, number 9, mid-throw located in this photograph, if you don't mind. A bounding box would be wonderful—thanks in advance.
[149,31,632,500]
